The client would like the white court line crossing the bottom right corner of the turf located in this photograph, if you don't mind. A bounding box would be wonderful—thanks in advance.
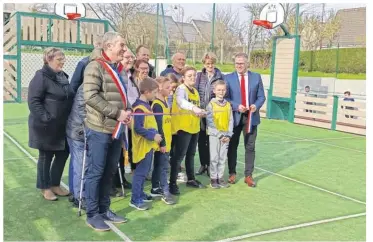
[218,213,366,242]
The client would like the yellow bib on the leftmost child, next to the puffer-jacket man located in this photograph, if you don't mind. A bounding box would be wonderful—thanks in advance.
[132,105,159,163]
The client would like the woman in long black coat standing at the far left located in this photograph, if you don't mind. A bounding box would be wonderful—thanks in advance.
[28,48,73,201]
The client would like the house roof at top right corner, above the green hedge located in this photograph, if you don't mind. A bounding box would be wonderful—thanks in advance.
[335,8,366,47]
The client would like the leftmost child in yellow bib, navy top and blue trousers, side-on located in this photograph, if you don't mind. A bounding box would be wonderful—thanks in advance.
[130,78,162,210]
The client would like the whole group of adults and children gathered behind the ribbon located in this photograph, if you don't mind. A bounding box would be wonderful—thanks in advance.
[28,32,265,231]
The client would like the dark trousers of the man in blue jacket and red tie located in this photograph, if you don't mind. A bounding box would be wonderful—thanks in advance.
[228,115,257,176]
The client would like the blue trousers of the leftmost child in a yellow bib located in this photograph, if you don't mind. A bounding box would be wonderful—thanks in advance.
[131,150,154,204]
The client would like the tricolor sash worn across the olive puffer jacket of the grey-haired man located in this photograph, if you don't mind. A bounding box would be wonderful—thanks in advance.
[97,60,128,149]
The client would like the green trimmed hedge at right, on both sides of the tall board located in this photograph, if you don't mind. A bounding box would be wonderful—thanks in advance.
[250,48,366,73]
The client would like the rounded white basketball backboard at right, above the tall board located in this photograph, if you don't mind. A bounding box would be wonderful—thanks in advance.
[260,3,285,28]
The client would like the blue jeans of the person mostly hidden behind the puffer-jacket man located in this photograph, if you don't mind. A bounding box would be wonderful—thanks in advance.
[67,138,87,199]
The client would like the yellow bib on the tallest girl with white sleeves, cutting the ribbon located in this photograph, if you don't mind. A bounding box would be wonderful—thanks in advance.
[171,84,200,134]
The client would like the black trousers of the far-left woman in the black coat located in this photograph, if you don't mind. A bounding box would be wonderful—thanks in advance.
[36,145,70,189]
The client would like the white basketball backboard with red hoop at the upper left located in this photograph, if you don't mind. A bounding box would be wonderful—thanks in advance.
[54,3,86,20]
